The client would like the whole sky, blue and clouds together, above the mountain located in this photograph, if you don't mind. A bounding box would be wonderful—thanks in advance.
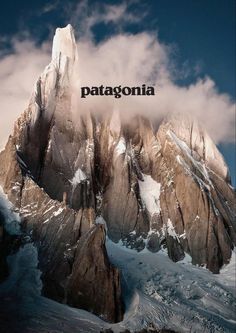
[0,0,236,185]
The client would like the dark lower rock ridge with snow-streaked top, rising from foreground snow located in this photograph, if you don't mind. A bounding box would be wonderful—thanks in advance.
[17,177,124,322]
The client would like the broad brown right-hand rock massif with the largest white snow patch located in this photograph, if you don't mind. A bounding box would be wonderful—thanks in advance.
[96,115,236,273]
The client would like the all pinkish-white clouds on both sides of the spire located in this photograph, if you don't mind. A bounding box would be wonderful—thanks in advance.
[0,1,235,147]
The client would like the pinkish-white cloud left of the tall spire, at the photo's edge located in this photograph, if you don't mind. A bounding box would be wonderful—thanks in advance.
[0,40,50,148]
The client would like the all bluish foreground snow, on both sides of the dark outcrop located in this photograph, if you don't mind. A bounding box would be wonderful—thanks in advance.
[0,189,236,333]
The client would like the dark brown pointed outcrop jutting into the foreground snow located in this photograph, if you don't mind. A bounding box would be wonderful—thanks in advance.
[67,225,123,322]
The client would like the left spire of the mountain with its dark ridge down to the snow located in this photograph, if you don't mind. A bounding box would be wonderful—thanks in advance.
[0,26,124,322]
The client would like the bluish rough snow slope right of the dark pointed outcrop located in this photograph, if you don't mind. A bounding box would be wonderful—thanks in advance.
[107,240,236,333]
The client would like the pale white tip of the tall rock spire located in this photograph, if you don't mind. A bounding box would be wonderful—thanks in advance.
[52,24,77,61]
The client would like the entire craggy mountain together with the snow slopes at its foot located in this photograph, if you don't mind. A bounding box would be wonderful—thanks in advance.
[0,25,236,333]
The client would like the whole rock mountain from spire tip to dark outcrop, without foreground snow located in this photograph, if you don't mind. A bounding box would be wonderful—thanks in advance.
[0,22,235,321]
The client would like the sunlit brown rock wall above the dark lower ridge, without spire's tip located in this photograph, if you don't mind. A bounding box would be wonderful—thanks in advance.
[0,27,233,273]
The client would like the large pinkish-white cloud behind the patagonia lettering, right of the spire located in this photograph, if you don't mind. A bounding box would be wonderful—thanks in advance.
[73,33,235,143]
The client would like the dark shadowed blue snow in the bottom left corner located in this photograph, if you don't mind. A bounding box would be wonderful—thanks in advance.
[0,243,107,333]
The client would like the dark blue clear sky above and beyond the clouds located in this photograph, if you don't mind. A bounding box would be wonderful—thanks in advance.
[0,0,236,184]
